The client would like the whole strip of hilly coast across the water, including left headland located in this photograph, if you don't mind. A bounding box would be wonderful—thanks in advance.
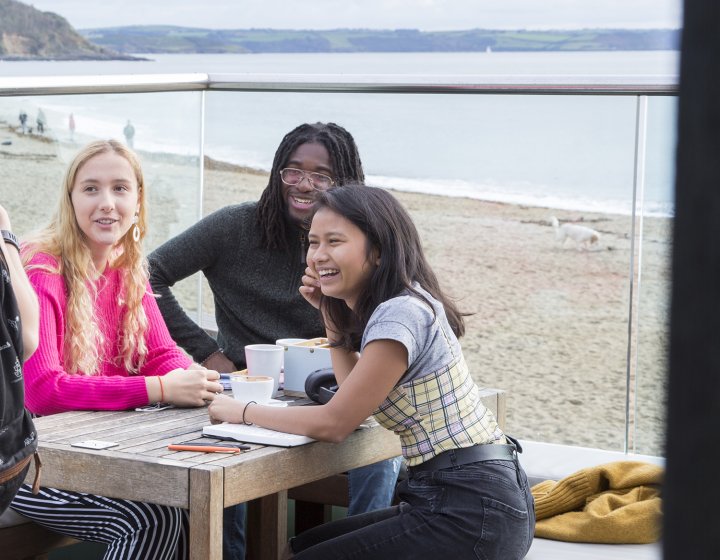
[0,0,680,60]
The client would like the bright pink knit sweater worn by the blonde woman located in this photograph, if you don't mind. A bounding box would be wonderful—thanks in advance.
[23,253,191,415]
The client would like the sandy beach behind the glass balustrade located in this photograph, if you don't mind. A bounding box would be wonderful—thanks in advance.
[0,123,672,454]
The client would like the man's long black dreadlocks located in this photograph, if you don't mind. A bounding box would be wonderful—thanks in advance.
[257,122,365,249]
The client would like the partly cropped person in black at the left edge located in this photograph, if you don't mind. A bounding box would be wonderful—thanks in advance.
[0,205,39,515]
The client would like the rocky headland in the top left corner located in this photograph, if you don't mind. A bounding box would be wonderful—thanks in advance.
[0,0,141,60]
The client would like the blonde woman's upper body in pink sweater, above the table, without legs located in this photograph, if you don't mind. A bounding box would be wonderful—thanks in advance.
[18,140,222,406]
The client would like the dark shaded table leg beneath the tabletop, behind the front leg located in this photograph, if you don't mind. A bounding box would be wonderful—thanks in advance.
[246,490,287,560]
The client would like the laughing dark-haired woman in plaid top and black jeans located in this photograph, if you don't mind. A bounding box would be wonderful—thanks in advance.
[208,185,535,560]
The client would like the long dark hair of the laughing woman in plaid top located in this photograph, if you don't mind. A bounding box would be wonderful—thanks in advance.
[316,184,465,350]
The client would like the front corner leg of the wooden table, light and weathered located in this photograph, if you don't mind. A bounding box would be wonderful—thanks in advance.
[190,465,224,560]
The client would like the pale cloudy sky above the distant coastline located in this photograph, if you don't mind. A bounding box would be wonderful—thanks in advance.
[24,0,682,31]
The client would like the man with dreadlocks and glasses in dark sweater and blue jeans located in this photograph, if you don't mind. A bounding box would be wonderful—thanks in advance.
[149,123,400,559]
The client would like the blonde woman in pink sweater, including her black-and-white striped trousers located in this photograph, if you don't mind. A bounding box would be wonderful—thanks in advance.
[11,140,222,560]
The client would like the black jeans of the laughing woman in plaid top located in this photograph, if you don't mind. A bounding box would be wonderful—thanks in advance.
[290,460,535,560]
